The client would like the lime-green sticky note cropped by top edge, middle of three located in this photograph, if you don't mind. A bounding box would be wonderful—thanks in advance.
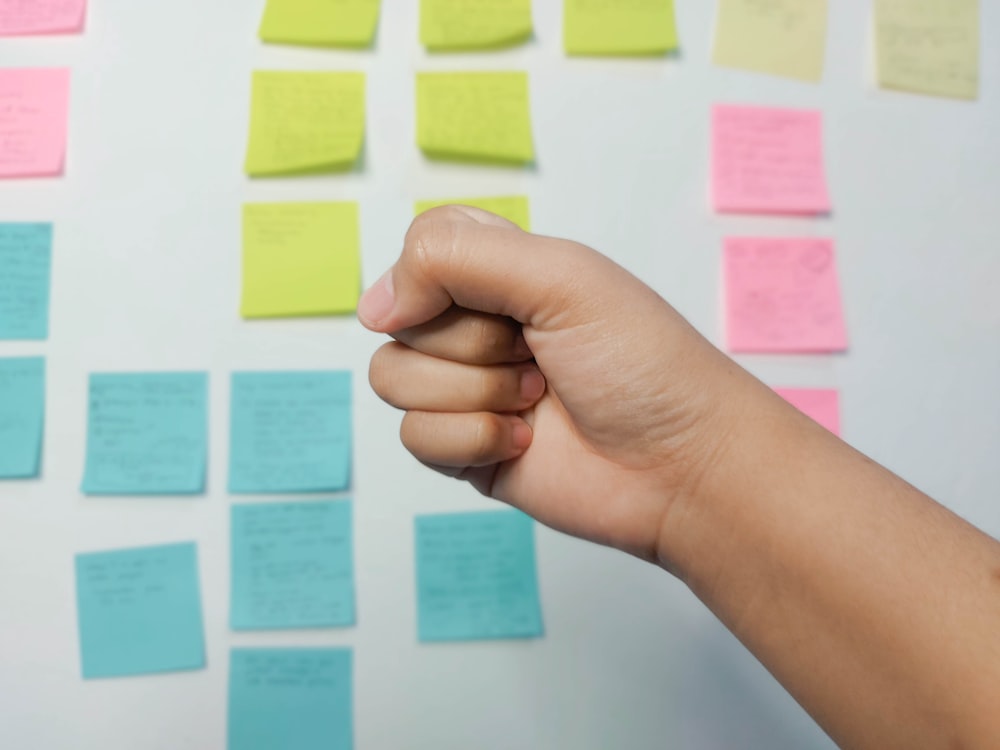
[420,0,532,51]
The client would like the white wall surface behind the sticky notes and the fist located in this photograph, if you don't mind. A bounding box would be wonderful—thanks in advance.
[0,0,1000,750]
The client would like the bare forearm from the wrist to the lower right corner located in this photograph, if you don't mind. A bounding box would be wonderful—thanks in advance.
[660,383,1000,750]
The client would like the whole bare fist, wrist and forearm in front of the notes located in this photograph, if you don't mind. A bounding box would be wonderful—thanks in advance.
[358,207,1000,750]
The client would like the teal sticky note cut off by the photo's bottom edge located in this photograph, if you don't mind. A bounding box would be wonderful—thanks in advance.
[226,648,354,750]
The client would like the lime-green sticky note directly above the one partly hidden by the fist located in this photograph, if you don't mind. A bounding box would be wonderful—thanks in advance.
[417,72,535,164]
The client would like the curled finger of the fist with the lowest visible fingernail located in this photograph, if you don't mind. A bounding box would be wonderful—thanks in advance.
[399,411,531,467]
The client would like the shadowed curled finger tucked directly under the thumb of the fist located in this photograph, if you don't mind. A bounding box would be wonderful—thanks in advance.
[392,306,532,365]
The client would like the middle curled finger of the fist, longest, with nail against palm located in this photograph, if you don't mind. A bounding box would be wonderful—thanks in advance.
[368,341,545,412]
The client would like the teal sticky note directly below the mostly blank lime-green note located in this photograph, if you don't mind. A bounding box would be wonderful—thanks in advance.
[229,371,351,494]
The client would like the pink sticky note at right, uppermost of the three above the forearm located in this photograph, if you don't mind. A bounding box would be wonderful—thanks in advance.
[712,105,830,214]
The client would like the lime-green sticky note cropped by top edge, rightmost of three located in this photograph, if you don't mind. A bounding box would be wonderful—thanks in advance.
[563,0,677,55]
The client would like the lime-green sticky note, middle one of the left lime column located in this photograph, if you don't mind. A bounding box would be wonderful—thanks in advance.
[244,71,365,176]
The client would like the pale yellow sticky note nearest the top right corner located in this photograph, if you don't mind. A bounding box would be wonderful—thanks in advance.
[875,0,979,99]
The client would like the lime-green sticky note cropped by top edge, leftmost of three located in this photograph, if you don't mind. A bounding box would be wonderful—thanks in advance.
[259,0,380,47]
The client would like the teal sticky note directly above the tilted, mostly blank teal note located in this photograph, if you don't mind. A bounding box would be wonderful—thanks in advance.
[83,372,208,495]
